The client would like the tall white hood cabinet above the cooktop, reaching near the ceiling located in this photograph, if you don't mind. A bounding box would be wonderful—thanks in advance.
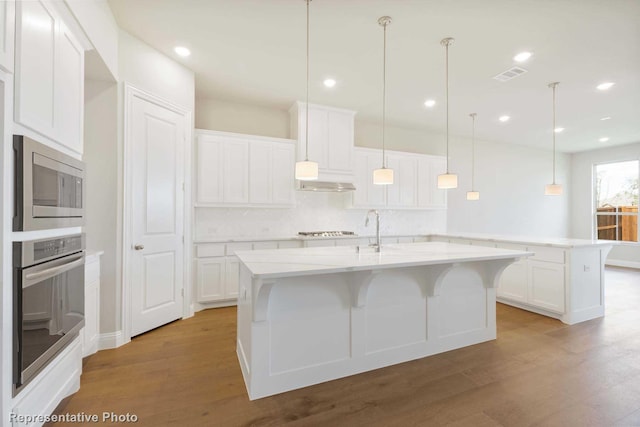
[289,102,356,182]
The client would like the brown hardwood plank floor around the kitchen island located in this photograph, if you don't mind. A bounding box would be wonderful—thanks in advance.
[48,268,640,427]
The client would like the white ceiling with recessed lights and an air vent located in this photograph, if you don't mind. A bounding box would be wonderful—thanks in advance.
[109,0,640,152]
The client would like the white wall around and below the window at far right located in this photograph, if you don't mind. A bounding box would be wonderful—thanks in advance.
[571,143,640,268]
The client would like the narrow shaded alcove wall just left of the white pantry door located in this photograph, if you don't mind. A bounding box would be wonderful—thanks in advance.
[84,80,121,332]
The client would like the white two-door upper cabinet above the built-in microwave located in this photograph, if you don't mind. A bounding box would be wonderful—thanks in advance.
[15,1,84,153]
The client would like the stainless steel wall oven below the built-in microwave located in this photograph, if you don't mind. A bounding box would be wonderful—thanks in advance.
[13,234,85,395]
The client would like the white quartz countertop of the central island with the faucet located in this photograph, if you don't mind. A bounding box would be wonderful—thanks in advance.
[236,242,533,279]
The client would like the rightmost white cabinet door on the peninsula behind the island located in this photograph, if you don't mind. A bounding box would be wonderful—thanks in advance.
[528,260,565,313]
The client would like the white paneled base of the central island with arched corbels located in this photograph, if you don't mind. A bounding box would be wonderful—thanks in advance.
[238,261,502,400]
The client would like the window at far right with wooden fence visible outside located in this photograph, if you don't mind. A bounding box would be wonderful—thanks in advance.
[595,160,640,242]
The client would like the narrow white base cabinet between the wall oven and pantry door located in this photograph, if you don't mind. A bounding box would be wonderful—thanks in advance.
[81,252,102,357]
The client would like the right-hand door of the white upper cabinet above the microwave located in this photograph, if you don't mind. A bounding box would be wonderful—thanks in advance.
[54,25,84,153]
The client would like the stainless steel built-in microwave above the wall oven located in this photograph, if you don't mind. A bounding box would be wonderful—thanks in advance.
[13,135,85,231]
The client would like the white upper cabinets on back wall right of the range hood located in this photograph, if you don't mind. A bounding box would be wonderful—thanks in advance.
[353,147,447,209]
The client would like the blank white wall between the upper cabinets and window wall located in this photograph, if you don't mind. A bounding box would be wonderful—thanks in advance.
[448,138,572,237]
